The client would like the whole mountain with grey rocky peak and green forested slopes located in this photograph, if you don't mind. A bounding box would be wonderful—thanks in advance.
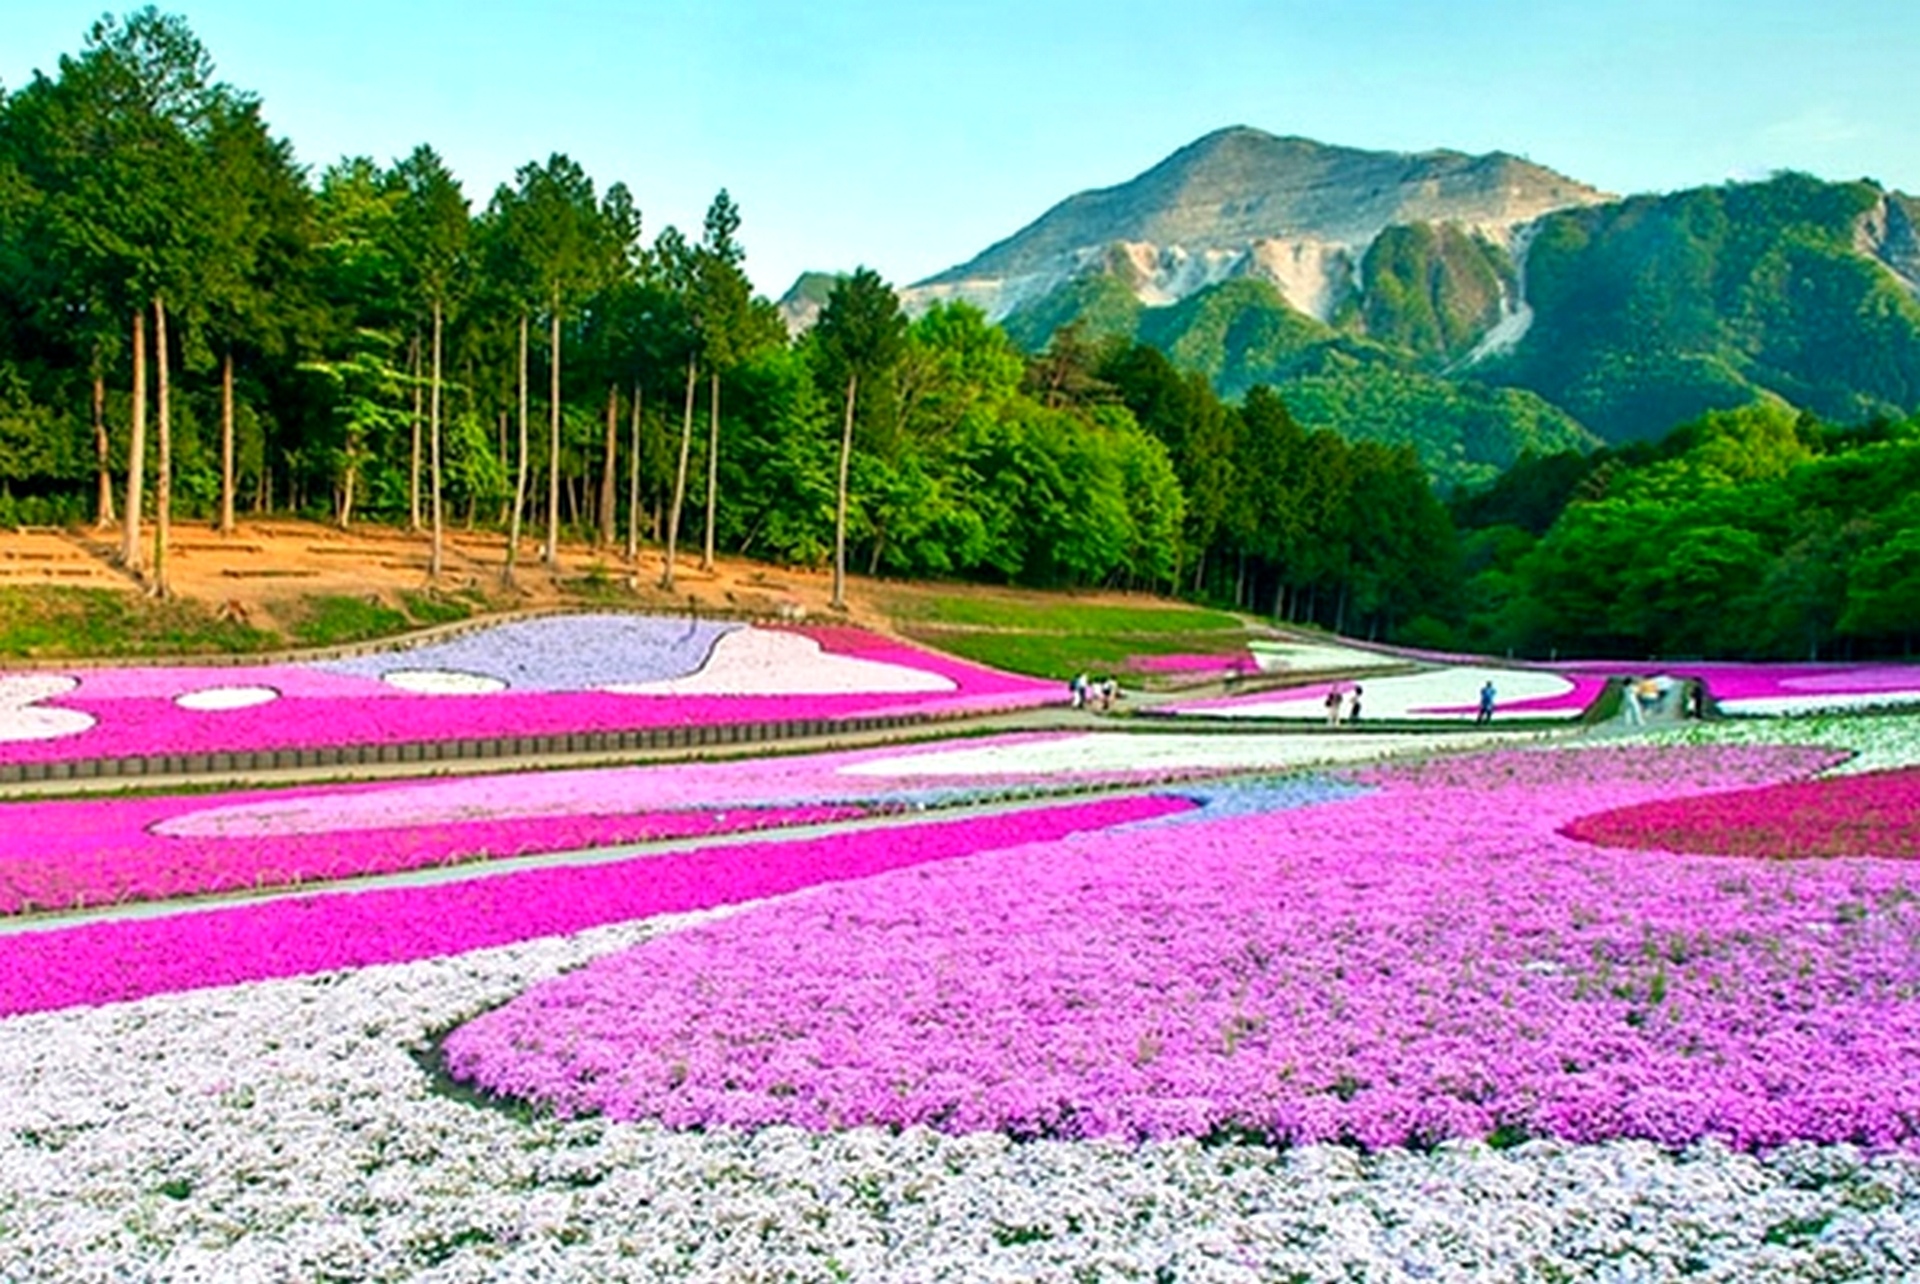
[771,129,1920,486]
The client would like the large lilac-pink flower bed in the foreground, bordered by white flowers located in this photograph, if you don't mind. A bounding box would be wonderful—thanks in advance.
[447,747,1920,1150]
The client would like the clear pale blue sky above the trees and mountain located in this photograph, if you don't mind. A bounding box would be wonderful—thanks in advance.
[0,0,1920,296]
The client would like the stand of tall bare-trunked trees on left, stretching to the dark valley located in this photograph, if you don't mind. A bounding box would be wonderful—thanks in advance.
[0,10,1452,644]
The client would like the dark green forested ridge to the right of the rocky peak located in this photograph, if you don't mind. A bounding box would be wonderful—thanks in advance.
[1480,175,1920,441]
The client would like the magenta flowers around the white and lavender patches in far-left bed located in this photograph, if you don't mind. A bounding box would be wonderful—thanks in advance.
[0,630,1062,762]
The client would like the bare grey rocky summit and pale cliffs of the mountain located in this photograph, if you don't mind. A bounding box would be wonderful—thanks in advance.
[902,127,1613,321]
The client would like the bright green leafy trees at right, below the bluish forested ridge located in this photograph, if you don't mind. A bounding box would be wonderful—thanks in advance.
[1455,405,1920,658]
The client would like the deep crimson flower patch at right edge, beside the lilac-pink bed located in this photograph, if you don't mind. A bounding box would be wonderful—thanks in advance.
[1563,768,1920,860]
